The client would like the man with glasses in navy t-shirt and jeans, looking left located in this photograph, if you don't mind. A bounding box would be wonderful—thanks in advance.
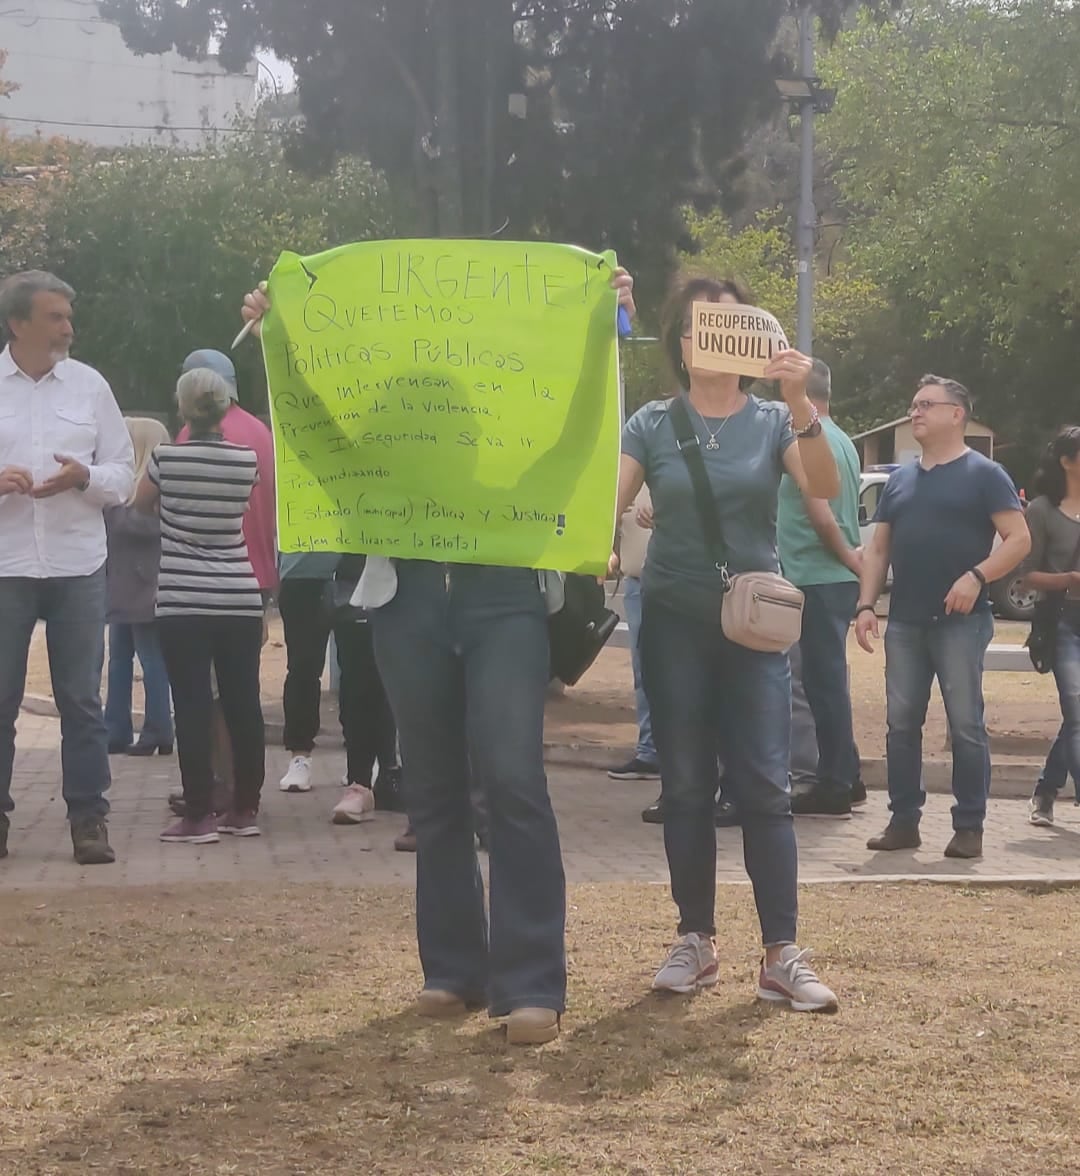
[855,375,1031,857]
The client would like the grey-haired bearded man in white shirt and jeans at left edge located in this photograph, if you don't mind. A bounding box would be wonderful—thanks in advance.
[0,270,134,866]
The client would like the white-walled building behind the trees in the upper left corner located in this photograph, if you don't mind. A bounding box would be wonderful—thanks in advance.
[0,0,259,147]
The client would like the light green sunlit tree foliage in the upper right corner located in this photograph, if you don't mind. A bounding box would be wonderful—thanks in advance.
[824,0,1080,458]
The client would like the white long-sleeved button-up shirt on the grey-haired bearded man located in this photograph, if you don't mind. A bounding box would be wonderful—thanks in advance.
[0,347,135,580]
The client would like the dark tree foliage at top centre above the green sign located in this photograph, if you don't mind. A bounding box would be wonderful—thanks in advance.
[102,0,887,308]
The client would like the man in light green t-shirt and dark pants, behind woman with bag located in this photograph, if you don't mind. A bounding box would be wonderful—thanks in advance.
[776,360,862,816]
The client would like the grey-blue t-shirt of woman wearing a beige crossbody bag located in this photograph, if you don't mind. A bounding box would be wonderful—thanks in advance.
[622,396,795,620]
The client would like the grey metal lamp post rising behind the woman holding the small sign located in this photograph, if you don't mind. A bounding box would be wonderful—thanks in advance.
[776,4,836,355]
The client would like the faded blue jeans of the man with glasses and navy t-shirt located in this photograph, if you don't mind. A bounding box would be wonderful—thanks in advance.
[885,609,994,831]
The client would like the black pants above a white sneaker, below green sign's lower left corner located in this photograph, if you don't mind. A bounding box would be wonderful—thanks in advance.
[278,579,331,755]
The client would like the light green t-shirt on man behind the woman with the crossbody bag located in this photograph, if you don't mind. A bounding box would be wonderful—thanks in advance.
[776,416,861,588]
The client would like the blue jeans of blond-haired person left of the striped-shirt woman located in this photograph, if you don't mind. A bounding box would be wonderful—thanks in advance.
[105,621,173,747]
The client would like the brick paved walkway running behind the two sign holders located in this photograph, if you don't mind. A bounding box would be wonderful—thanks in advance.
[0,714,1080,890]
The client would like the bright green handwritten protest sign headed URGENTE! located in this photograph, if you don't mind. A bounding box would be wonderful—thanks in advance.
[262,241,621,574]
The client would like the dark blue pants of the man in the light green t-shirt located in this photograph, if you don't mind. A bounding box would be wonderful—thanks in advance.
[799,583,859,796]
